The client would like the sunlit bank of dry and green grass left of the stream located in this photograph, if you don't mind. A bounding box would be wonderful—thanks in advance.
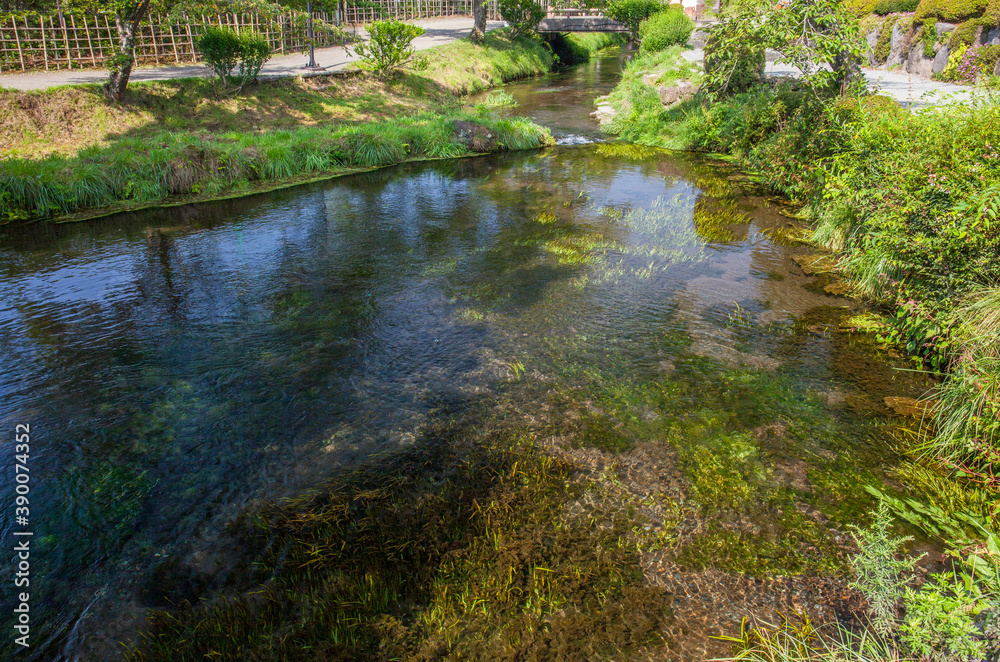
[0,31,552,222]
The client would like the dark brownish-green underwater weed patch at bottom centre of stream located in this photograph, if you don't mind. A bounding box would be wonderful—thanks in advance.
[127,430,667,662]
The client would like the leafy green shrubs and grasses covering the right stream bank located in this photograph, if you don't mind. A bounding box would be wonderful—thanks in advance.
[606,48,1000,660]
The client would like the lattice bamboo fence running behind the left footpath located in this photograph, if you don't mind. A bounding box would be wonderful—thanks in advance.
[0,0,499,72]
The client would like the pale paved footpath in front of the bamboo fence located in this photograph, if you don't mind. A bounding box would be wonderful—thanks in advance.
[0,16,505,90]
